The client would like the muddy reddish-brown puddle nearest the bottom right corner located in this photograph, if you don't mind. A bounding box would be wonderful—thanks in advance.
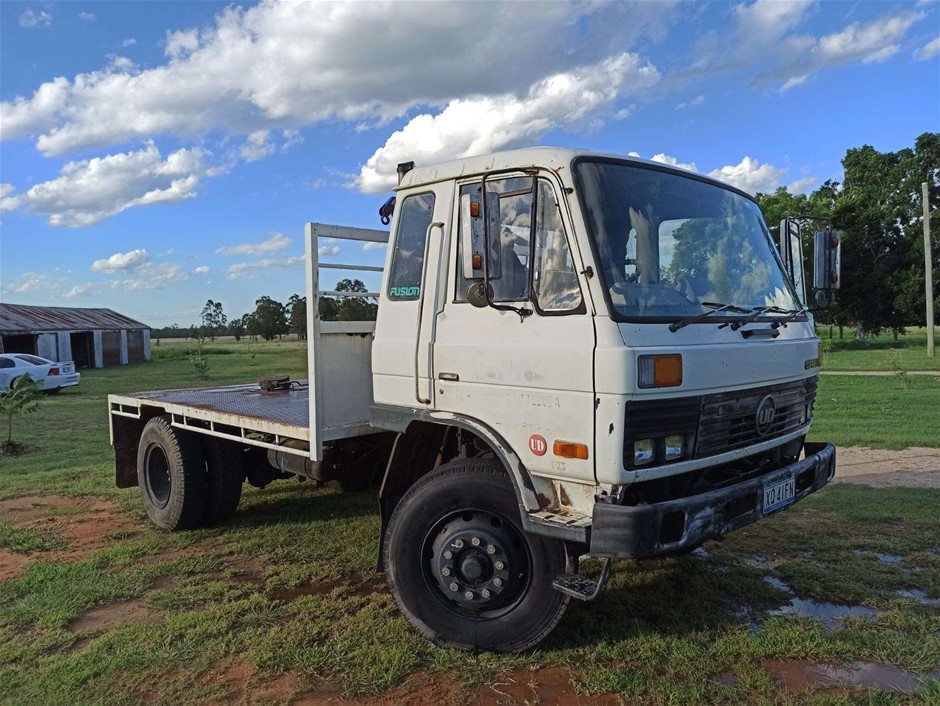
[765,660,921,694]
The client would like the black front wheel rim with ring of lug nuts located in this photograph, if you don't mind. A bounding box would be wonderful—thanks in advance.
[421,508,532,620]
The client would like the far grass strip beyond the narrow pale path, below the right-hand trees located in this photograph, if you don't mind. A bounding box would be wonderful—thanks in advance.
[817,326,940,372]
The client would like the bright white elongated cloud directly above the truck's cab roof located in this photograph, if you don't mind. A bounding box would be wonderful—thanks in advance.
[354,53,659,192]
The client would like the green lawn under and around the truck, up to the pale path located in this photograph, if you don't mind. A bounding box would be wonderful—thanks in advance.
[0,334,940,704]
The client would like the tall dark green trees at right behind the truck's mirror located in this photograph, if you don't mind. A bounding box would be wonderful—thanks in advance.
[757,132,940,337]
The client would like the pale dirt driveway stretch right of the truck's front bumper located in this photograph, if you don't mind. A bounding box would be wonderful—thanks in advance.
[834,446,940,488]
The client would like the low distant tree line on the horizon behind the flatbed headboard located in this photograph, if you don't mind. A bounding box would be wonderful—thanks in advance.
[151,279,378,341]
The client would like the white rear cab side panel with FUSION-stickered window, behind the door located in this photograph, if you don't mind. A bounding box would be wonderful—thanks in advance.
[372,182,454,408]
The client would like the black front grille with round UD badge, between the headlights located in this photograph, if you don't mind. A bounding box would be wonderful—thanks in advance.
[623,377,816,468]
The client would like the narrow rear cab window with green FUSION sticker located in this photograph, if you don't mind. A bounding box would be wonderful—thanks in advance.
[388,193,434,301]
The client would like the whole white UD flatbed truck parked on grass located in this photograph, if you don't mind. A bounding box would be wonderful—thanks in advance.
[109,148,839,651]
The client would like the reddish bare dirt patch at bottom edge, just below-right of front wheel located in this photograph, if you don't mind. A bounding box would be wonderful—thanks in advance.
[473,667,620,706]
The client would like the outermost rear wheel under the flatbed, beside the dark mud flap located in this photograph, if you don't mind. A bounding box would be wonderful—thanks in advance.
[137,416,206,531]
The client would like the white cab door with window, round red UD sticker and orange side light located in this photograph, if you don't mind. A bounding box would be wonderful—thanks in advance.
[433,173,595,482]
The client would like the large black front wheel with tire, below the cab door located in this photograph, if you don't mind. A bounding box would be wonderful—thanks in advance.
[384,459,569,652]
